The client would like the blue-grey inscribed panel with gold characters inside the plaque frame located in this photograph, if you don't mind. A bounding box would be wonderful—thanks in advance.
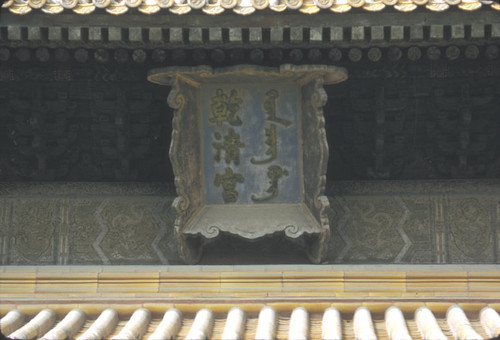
[200,84,302,204]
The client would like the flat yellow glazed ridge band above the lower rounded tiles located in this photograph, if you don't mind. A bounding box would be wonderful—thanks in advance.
[0,265,500,303]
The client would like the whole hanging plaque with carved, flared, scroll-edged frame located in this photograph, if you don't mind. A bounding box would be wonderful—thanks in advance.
[148,64,347,263]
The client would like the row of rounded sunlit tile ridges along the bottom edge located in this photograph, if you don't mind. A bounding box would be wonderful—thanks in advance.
[0,305,500,340]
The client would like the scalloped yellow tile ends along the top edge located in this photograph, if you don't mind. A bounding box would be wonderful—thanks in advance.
[2,0,500,15]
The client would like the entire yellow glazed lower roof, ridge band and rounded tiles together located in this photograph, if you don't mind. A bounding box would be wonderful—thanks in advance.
[0,265,500,340]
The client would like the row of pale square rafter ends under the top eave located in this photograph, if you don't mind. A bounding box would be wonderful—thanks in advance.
[0,10,500,49]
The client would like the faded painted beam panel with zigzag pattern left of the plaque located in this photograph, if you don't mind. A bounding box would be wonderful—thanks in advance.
[0,183,179,265]
